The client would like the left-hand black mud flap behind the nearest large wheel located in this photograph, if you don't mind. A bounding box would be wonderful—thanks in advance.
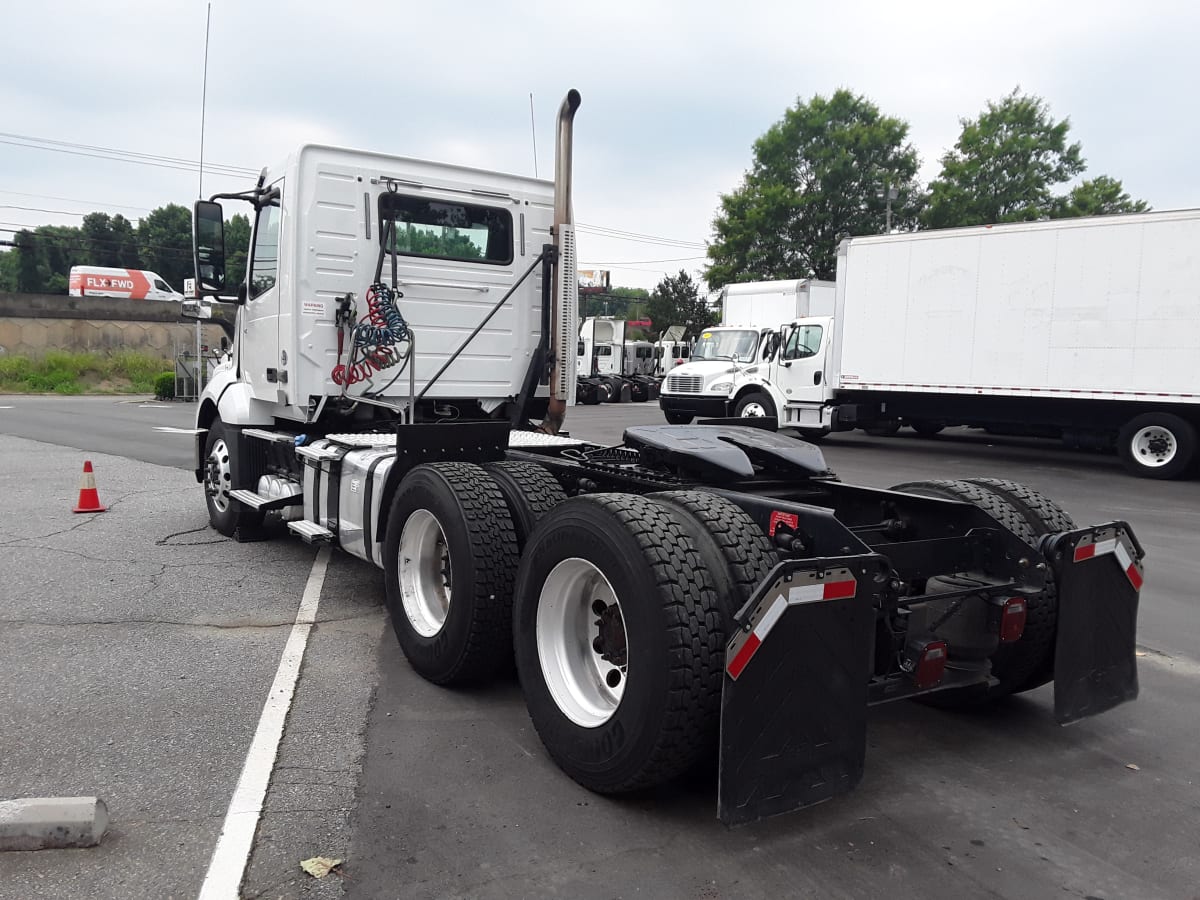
[718,554,888,826]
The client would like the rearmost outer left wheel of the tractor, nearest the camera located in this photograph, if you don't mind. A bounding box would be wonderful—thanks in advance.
[514,493,725,793]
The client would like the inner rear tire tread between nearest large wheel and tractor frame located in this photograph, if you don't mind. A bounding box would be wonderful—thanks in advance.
[650,491,779,632]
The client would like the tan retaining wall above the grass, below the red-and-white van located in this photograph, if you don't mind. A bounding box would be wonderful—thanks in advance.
[0,293,224,359]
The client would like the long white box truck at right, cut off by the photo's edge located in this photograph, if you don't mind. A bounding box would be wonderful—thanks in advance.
[730,210,1200,478]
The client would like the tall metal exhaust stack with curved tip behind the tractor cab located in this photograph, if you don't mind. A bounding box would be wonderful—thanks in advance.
[541,89,580,434]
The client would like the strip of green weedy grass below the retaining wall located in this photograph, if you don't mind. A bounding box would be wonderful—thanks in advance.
[0,350,172,394]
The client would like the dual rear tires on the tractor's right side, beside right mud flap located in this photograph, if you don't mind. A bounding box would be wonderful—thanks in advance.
[892,478,1075,708]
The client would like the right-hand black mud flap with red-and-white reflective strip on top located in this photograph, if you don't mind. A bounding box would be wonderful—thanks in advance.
[1049,522,1144,725]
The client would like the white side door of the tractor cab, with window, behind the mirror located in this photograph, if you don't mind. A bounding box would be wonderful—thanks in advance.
[241,188,287,403]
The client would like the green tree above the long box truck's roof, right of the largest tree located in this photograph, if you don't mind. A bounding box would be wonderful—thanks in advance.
[922,89,1085,228]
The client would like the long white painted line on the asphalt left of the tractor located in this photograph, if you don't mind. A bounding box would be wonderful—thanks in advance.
[199,547,329,900]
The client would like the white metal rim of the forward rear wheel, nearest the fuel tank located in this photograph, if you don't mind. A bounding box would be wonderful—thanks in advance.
[396,509,452,637]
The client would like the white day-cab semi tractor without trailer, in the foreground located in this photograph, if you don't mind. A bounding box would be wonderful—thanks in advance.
[190,91,1142,823]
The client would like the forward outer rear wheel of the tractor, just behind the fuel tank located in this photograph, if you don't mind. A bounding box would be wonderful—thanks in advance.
[383,462,518,684]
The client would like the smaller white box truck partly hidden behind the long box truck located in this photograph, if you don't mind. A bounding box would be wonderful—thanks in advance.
[659,278,834,425]
